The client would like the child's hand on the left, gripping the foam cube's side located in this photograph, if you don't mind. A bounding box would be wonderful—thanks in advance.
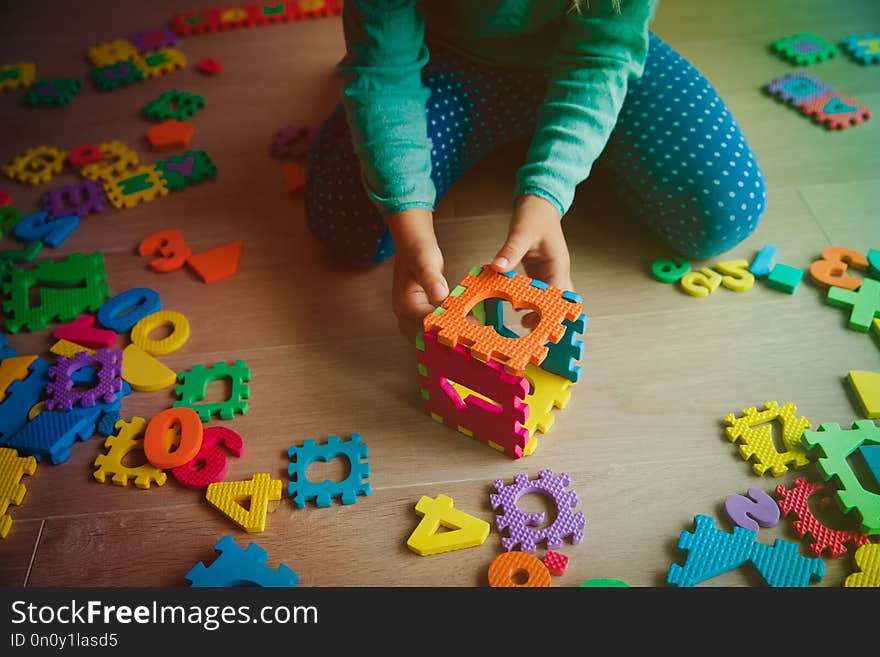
[388,209,449,340]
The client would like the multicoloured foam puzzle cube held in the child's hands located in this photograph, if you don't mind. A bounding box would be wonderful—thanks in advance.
[416,266,587,459]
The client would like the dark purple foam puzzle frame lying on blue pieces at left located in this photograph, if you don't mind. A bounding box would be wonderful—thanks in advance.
[46,349,122,411]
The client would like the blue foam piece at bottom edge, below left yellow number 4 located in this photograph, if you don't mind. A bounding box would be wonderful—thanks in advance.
[184,536,299,588]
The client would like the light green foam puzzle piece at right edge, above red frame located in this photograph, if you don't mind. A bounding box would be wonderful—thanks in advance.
[803,420,880,534]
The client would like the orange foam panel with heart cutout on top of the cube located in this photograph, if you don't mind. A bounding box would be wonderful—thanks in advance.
[424,266,583,376]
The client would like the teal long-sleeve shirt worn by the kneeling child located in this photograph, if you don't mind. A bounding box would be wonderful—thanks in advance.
[338,0,659,217]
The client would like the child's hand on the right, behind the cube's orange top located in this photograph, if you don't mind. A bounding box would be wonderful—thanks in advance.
[492,194,573,328]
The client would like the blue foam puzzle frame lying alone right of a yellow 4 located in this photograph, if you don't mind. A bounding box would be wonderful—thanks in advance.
[287,433,370,509]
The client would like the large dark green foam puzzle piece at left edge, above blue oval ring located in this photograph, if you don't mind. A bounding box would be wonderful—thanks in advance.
[3,251,110,333]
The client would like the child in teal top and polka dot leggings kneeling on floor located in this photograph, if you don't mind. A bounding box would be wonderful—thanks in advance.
[306,0,766,332]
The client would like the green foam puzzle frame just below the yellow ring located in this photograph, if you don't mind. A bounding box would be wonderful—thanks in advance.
[174,360,251,422]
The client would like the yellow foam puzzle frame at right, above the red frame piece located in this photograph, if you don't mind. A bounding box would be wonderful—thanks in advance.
[724,401,810,477]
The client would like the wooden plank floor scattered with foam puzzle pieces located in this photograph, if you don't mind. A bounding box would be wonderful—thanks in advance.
[0,0,880,586]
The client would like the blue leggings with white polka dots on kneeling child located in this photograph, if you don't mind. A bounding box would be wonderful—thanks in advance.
[305,34,767,265]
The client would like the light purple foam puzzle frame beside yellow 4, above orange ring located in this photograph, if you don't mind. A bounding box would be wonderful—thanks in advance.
[489,470,587,552]
